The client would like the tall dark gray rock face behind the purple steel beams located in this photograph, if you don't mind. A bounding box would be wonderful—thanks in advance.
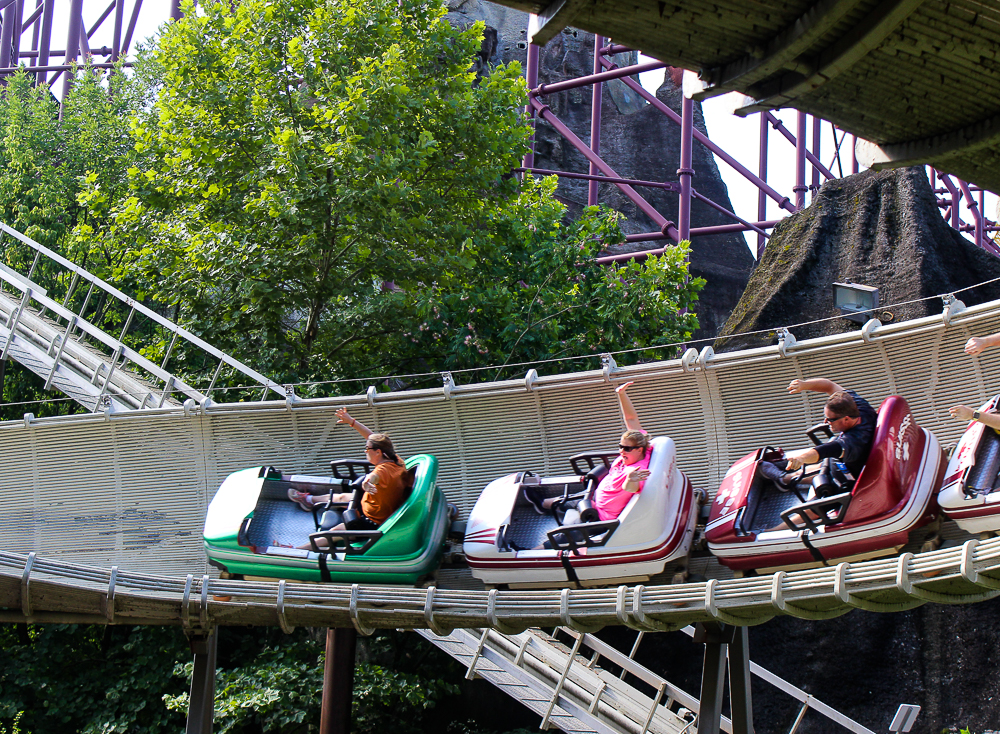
[448,0,754,338]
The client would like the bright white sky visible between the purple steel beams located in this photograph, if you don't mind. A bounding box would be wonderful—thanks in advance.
[45,0,998,258]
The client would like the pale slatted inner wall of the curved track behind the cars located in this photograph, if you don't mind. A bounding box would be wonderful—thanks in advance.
[0,302,1000,575]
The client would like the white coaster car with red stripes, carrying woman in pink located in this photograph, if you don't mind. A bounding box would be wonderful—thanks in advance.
[464,437,698,588]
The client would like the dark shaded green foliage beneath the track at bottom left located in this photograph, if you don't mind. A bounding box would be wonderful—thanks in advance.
[0,625,492,734]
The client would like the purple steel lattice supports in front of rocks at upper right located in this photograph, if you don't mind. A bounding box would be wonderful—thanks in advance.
[520,32,1000,263]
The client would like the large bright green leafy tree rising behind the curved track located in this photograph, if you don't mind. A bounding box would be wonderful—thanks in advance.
[95,0,700,390]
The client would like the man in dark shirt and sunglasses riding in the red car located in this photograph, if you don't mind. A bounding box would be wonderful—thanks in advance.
[761,377,877,487]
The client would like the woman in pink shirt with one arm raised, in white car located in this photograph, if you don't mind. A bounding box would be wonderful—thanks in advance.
[524,382,652,525]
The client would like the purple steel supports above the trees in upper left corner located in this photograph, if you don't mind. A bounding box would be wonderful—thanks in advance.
[0,0,181,105]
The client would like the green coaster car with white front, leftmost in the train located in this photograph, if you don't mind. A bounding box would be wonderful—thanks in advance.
[204,454,449,585]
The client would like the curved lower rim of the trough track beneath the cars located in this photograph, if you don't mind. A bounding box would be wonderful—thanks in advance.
[0,538,1000,636]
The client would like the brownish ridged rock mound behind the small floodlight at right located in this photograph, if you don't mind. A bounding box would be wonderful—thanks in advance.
[715,167,1000,351]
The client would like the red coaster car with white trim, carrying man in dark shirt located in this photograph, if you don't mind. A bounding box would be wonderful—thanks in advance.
[706,396,945,571]
